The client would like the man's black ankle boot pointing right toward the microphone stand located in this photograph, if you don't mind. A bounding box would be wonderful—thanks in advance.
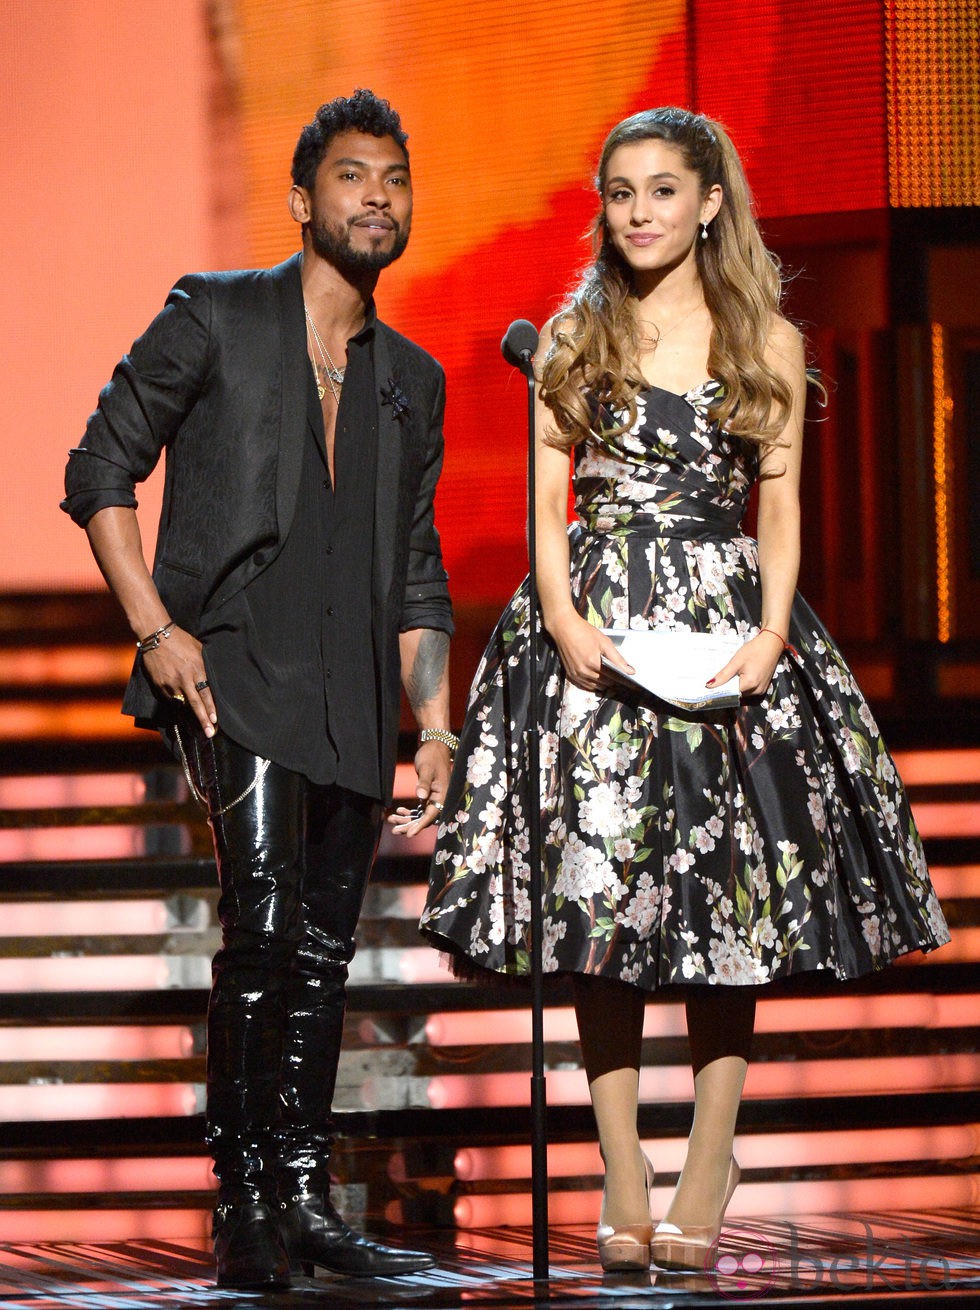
[273,1192,435,1277]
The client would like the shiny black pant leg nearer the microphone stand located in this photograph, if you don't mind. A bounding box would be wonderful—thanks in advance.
[276,787,383,1203]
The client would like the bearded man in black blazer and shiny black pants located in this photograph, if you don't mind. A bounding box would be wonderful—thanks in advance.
[63,90,455,1288]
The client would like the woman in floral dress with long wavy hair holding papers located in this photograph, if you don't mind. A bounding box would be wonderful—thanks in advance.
[394,109,949,1269]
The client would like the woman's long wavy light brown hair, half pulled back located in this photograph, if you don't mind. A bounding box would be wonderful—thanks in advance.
[540,106,793,451]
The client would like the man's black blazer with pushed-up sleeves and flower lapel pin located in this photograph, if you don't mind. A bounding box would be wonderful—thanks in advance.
[62,255,452,794]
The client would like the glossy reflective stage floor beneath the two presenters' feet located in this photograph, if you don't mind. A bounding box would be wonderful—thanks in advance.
[0,1210,980,1310]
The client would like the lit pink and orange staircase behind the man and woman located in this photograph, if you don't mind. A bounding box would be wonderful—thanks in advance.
[0,596,980,1242]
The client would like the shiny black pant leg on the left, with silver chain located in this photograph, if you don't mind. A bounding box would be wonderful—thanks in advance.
[189,732,308,1208]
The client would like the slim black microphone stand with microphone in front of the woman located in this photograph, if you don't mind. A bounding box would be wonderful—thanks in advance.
[500,320,549,1282]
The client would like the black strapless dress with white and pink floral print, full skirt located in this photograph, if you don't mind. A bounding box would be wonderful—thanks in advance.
[422,381,949,990]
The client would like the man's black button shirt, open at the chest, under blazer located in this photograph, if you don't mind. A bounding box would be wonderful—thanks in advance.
[202,305,381,799]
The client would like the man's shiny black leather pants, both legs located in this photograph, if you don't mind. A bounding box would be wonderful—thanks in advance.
[183,732,383,1205]
